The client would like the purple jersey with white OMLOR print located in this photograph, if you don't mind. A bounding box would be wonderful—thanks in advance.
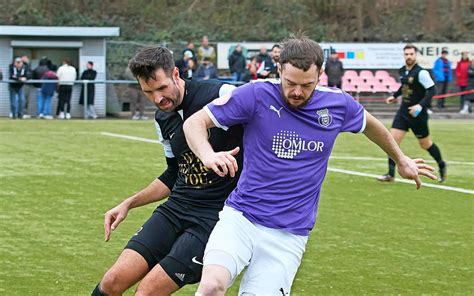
[204,80,365,235]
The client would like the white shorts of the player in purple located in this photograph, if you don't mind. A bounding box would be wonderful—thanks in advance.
[203,206,308,296]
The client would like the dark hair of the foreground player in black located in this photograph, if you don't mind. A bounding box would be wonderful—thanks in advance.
[128,46,175,81]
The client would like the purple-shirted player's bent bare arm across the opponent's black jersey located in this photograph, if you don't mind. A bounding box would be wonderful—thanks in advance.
[183,108,240,177]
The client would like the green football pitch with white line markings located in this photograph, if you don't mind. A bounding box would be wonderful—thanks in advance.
[0,119,474,295]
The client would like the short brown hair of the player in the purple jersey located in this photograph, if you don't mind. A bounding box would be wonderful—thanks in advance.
[280,36,324,72]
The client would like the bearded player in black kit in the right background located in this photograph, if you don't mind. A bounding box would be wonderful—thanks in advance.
[377,44,447,182]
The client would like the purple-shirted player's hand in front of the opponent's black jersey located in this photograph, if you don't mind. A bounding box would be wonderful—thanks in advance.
[202,147,240,177]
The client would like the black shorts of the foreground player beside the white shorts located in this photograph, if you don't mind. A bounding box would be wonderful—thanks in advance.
[125,207,210,287]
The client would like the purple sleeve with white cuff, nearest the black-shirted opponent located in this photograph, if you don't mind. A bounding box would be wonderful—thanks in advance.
[204,83,256,130]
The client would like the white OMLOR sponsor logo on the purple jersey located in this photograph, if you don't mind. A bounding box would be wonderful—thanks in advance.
[272,130,324,159]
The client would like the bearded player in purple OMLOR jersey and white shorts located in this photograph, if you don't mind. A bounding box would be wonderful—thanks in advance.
[184,38,436,295]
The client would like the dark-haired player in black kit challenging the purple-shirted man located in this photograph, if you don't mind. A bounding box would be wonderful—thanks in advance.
[92,47,243,295]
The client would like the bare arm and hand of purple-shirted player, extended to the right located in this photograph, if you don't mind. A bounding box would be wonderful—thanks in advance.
[364,111,436,189]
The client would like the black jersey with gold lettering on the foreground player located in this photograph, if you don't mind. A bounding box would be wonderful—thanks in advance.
[155,80,243,227]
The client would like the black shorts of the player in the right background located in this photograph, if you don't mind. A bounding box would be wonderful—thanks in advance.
[392,109,430,139]
